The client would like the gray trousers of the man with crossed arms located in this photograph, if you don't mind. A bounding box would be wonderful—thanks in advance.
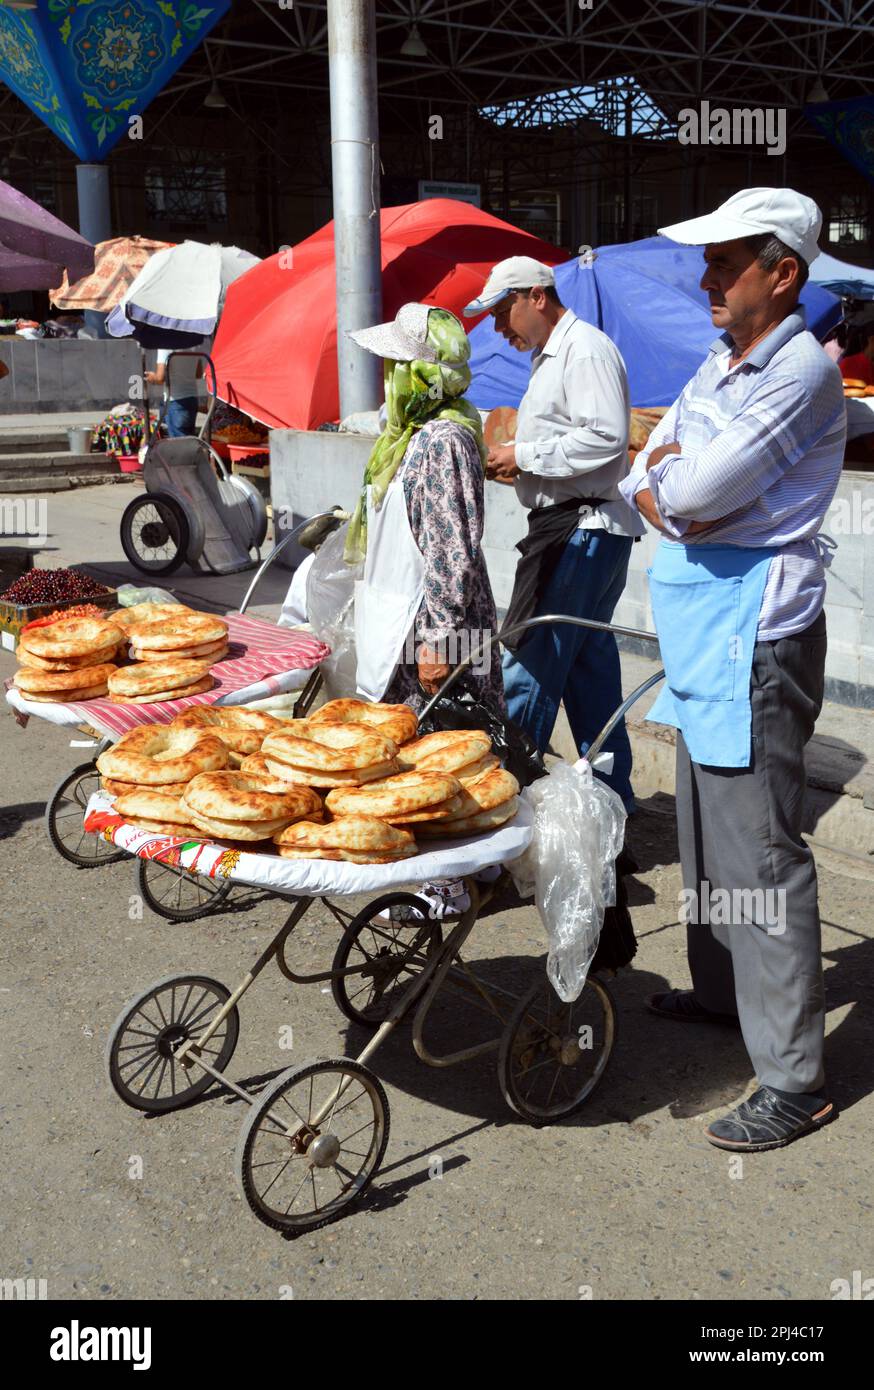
[677,613,825,1091]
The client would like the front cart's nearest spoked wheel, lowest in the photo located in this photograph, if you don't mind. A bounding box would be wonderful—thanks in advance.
[236,1058,389,1234]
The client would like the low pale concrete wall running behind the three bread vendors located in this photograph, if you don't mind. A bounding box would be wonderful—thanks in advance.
[270,430,874,709]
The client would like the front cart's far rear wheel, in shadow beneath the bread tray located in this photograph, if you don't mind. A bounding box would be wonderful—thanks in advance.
[331,892,443,1027]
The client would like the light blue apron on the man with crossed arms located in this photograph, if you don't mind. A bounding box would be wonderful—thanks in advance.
[646,541,781,767]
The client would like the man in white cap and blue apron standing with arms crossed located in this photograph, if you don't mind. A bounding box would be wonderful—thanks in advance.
[622,188,846,1151]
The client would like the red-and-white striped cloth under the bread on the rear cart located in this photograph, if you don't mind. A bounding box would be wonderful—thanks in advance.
[7,613,329,738]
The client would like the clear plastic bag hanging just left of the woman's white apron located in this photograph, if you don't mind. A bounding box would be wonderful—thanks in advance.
[307,523,364,699]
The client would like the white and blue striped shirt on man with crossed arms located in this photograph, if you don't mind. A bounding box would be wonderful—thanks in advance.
[620,309,846,641]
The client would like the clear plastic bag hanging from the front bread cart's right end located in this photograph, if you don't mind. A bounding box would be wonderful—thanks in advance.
[507,759,625,1004]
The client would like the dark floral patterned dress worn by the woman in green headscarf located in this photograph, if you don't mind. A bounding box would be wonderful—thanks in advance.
[384,420,504,713]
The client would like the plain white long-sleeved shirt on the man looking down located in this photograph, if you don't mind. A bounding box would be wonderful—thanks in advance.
[516,309,645,535]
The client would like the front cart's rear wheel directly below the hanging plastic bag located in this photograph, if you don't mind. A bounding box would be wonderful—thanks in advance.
[497,974,618,1126]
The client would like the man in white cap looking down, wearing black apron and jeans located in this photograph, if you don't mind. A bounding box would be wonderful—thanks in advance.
[464,256,645,812]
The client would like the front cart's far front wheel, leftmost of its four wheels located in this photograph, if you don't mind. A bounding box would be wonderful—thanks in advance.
[106,974,240,1115]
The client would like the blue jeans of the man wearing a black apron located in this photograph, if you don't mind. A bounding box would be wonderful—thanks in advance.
[503,530,634,810]
